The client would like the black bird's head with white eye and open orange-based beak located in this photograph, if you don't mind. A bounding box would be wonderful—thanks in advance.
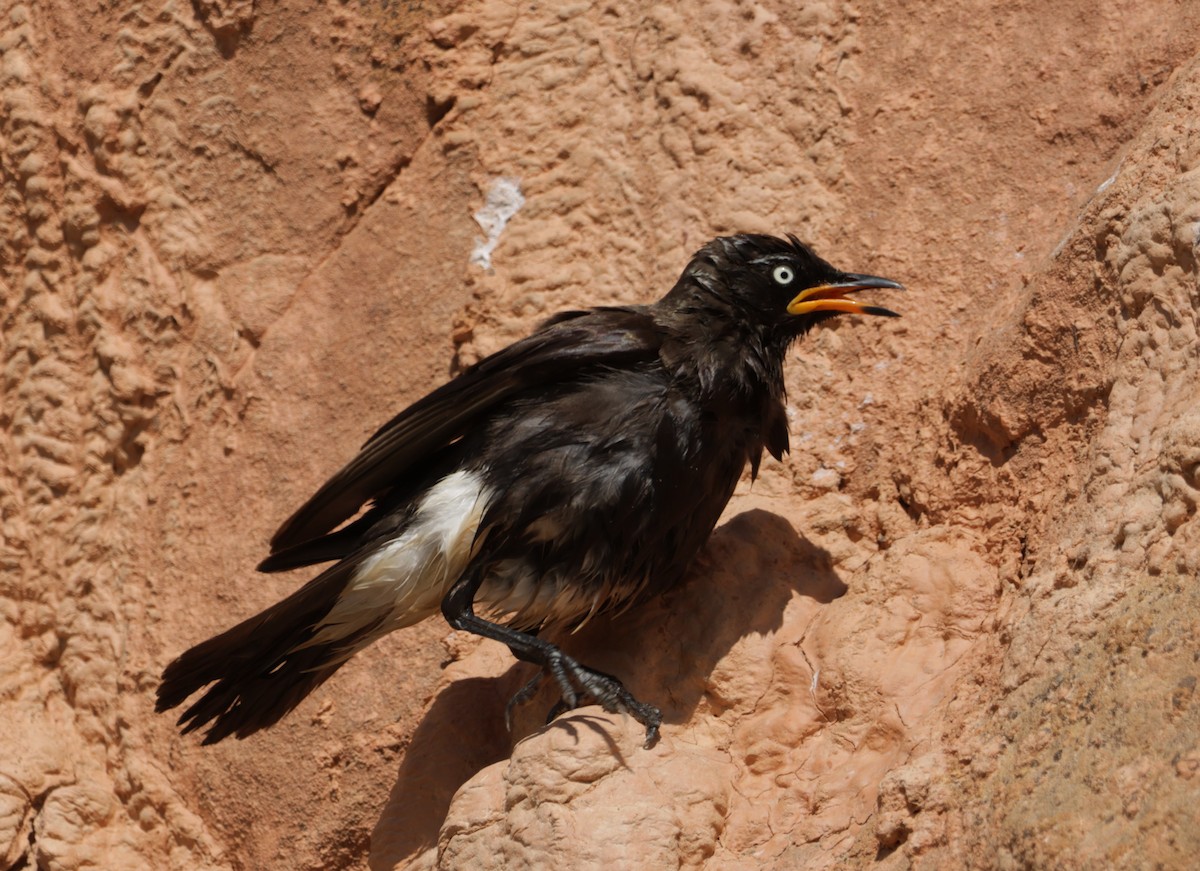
[667,234,904,342]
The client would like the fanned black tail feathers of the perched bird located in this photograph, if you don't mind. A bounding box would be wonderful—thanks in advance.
[155,560,364,744]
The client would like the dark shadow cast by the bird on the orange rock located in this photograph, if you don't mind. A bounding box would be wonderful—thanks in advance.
[370,510,847,869]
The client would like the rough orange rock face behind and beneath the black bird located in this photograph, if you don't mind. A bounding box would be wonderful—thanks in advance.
[0,0,1200,871]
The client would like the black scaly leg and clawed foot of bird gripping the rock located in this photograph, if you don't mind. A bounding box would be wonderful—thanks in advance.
[442,572,662,747]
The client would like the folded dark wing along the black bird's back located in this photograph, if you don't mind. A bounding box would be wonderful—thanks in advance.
[264,306,661,556]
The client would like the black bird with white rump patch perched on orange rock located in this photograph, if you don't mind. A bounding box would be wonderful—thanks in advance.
[155,234,904,747]
